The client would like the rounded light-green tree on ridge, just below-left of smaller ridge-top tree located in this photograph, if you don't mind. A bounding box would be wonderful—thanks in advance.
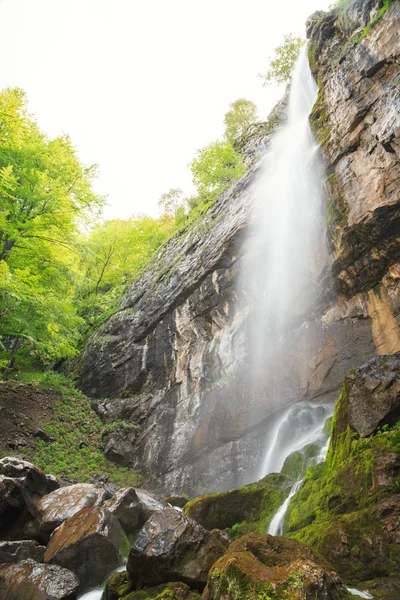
[190,142,246,204]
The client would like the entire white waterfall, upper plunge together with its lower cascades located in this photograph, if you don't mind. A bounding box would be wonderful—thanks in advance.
[80,49,372,600]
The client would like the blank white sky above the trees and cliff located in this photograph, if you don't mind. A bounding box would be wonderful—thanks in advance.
[0,0,332,218]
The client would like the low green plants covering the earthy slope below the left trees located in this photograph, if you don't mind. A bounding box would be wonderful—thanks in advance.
[7,372,141,486]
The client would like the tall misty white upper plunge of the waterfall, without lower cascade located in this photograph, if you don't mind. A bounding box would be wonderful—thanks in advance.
[238,48,326,460]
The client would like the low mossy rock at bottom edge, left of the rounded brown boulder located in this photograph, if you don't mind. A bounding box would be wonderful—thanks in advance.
[102,571,200,600]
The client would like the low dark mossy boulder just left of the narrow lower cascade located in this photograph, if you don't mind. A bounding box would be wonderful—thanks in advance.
[184,473,293,537]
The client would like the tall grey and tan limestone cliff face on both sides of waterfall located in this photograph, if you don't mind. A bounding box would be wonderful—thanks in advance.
[79,0,400,495]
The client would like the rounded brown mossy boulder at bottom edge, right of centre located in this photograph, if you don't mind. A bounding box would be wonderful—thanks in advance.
[202,533,347,600]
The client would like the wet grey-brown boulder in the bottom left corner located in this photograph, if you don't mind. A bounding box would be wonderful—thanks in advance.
[0,560,79,600]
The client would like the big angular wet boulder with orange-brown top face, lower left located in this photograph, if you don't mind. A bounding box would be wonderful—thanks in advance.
[44,506,129,591]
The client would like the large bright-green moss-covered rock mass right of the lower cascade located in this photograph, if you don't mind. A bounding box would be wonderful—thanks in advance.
[285,386,400,583]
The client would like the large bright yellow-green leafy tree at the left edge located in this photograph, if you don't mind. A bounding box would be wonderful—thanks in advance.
[0,89,103,367]
